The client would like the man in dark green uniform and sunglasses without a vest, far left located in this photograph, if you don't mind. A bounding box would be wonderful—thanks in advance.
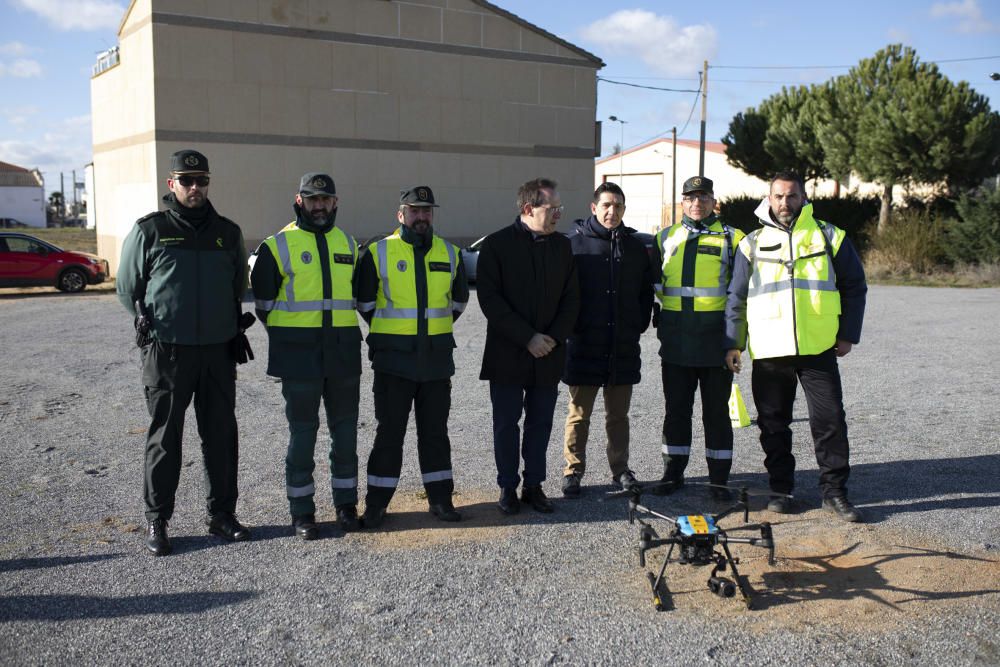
[117,150,250,556]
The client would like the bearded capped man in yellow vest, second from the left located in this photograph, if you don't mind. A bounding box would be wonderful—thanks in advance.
[250,173,361,540]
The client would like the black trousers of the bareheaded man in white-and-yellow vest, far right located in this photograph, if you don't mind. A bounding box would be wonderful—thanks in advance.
[753,350,851,498]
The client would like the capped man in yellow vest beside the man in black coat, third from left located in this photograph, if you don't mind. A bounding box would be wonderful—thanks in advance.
[356,185,469,528]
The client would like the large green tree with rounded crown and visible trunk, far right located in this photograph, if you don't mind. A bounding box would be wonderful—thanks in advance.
[817,44,1000,233]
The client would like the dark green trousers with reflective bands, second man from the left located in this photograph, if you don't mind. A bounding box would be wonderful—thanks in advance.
[281,377,361,516]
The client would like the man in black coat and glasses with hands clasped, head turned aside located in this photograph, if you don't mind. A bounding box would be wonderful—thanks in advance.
[476,178,580,514]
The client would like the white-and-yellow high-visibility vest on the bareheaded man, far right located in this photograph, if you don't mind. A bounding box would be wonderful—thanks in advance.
[739,204,846,359]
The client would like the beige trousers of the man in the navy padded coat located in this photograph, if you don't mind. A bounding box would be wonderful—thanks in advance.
[563,384,632,479]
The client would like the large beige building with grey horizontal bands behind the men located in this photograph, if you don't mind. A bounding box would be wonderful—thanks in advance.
[91,0,603,270]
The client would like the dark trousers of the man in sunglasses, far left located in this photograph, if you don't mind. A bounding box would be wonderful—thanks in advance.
[142,342,239,521]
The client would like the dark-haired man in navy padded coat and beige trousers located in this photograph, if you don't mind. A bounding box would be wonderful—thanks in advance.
[562,183,656,498]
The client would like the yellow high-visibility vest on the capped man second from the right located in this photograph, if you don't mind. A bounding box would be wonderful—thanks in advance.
[653,220,743,311]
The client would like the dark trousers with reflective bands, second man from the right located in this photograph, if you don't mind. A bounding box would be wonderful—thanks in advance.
[661,362,733,484]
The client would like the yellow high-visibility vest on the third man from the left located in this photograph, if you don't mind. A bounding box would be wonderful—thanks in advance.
[371,230,458,336]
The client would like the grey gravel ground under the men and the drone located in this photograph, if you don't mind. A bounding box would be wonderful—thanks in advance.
[0,287,1000,665]
